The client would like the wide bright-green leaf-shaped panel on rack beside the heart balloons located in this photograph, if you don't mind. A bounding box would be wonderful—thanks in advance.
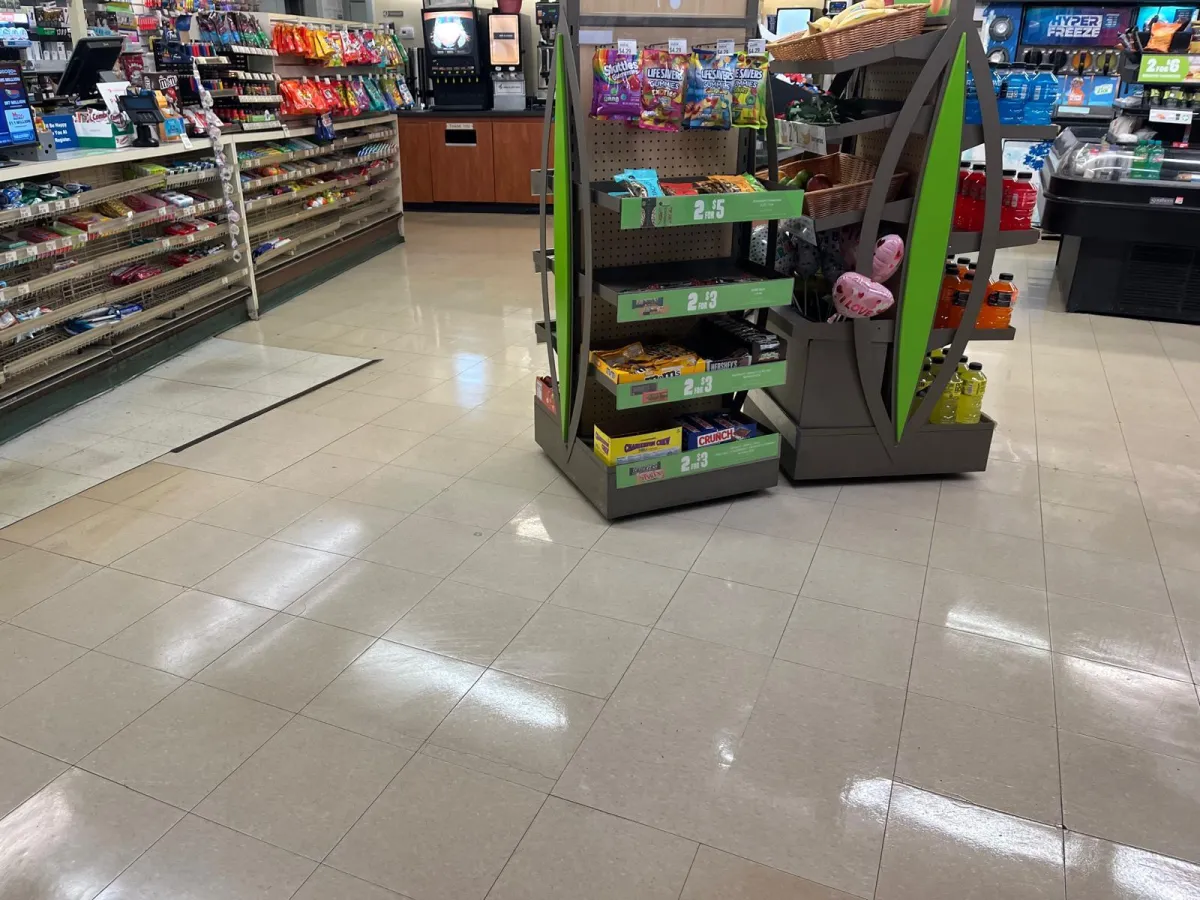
[892,36,973,442]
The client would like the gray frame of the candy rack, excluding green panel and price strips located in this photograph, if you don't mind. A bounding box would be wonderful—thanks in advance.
[532,0,779,518]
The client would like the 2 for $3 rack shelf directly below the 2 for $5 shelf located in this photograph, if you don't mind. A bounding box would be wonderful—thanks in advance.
[595,254,794,322]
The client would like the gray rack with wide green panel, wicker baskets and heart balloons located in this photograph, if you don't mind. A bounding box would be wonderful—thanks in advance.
[746,0,1057,480]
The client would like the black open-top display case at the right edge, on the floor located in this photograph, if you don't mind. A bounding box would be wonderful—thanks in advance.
[1040,126,1200,323]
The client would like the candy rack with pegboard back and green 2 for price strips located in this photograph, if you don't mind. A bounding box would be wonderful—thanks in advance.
[534,0,804,518]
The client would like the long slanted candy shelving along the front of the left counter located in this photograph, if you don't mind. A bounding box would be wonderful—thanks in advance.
[0,115,403,422]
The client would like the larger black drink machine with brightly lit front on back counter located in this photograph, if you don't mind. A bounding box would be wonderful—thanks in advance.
[421,6,492,110]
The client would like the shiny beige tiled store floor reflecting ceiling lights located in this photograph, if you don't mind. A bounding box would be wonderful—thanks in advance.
[0,215,1200,900]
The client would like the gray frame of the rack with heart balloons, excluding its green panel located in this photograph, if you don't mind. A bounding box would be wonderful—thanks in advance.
[745,0,1057,481]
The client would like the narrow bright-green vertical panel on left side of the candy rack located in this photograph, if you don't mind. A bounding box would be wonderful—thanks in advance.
[554,35,575,442]
